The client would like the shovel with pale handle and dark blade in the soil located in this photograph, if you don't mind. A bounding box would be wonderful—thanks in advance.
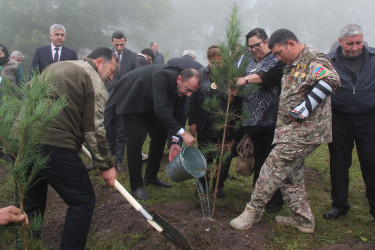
[82,145,191,250]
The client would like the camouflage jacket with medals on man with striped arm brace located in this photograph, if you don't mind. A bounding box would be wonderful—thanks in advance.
[273,46,340,144]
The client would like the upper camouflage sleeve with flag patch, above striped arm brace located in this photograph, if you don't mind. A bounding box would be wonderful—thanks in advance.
[309,55,341,92]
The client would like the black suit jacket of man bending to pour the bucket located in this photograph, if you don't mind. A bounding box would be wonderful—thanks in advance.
[115,64,182,135]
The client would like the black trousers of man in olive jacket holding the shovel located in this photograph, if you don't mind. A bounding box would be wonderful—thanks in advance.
[24,146,95,249]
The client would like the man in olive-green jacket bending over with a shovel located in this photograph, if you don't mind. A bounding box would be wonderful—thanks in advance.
[24,48,116,249]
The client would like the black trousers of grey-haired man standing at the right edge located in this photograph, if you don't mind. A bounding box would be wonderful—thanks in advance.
[328,113,375,218]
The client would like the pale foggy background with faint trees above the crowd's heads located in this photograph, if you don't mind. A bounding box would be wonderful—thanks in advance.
[0,0,375,73]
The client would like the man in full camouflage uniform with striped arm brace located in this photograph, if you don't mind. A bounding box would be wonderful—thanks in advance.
[230,29,340,233]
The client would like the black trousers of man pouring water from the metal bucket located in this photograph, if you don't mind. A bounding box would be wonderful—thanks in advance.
[123,110,168,190]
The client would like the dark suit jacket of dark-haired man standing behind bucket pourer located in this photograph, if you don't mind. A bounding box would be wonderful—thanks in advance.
[105,49,139,110]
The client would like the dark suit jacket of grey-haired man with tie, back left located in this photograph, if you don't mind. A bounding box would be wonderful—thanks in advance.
[31,44,78,72]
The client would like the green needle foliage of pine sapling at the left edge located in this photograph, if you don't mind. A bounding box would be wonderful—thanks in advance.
[0,74,65,249]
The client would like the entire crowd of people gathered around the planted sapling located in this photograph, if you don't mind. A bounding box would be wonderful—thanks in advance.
[0,24,375,249]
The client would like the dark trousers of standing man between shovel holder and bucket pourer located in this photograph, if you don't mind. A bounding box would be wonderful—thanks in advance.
[104,105,126,163]
